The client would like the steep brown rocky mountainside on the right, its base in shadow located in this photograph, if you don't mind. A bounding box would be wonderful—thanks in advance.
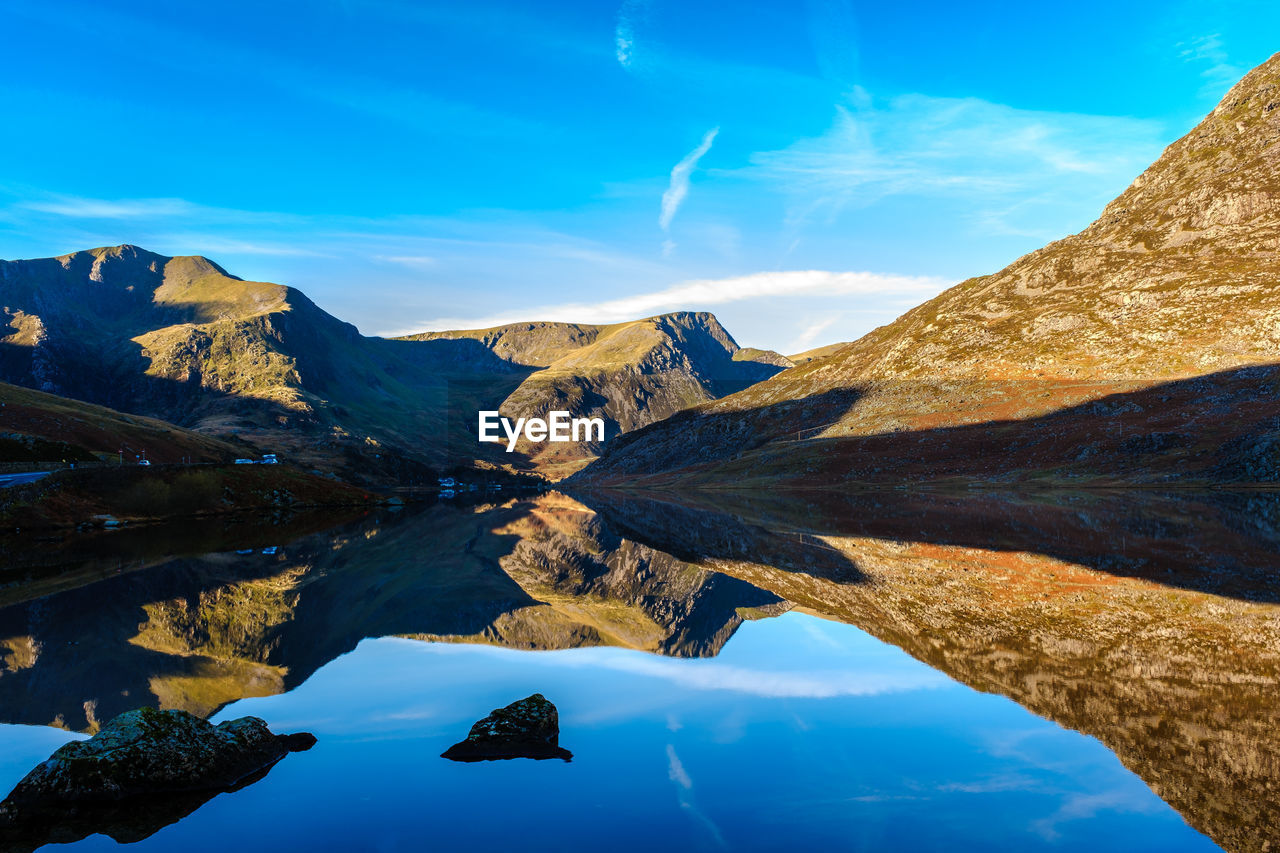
[580,54,1280,485]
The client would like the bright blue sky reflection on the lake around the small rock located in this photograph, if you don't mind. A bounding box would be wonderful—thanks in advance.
[0,612,1217,852]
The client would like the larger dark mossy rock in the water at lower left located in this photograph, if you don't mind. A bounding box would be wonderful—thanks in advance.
[0,708,315,850]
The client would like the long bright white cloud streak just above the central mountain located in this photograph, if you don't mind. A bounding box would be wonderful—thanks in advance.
[397,270,952,341]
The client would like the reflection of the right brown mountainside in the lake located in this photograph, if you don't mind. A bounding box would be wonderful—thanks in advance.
[591,492,1280,853]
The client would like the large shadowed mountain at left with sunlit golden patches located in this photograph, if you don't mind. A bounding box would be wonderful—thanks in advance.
[0,246,452,474]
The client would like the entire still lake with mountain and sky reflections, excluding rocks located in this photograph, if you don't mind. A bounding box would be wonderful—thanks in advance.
[0,484,1280,852]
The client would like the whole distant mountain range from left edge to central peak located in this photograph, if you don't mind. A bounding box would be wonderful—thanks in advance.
[0,246,787,483]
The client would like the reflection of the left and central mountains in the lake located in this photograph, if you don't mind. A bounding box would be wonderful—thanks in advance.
[0,496,785,730]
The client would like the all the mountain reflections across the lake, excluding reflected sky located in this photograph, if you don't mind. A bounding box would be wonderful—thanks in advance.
[0,492,1280,850]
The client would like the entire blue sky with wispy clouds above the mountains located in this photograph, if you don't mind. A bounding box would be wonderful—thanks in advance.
[0,0,1280,352]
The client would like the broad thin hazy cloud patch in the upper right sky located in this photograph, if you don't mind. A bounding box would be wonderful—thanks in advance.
[737,92,1165,237]
